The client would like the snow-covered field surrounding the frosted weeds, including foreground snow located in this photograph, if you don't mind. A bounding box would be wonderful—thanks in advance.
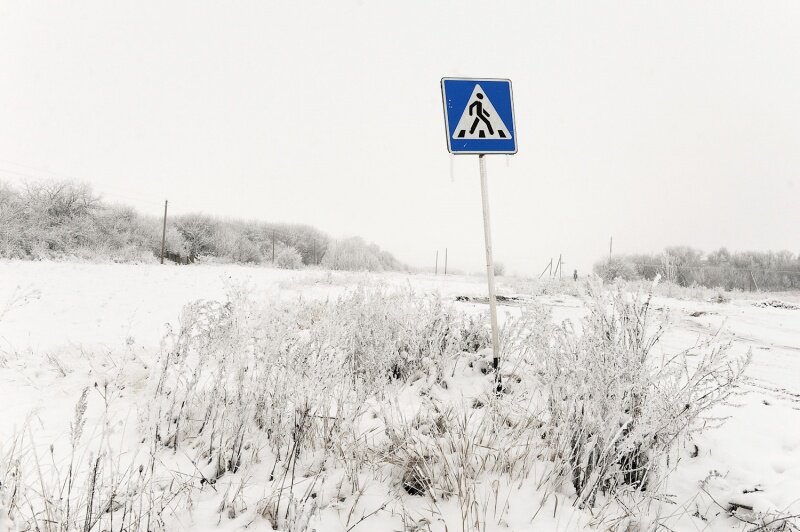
[0,262,800,532]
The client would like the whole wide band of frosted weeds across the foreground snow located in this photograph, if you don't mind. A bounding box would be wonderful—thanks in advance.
[0,284,747,532]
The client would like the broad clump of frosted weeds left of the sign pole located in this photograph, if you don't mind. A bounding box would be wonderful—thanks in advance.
[144,290,486,502]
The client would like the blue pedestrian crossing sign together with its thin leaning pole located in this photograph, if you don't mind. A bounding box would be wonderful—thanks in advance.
[442,78,517,378]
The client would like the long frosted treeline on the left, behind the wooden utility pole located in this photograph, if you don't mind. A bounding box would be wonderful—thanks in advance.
[0,181,405,271]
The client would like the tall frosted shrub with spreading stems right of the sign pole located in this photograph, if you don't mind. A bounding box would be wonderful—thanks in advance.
[535,278,749,505]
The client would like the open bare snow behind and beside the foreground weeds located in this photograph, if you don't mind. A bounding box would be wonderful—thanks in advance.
[0,261,800,531]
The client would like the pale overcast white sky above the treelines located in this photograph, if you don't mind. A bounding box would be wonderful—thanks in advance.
[0,0,800,275]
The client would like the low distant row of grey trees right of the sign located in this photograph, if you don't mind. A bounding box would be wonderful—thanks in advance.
[594,246,800,290]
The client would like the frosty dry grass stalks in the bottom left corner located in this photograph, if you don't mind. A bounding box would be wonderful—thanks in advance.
[0,388,185,532]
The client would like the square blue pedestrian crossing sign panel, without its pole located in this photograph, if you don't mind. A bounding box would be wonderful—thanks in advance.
[442,78,517,154]
